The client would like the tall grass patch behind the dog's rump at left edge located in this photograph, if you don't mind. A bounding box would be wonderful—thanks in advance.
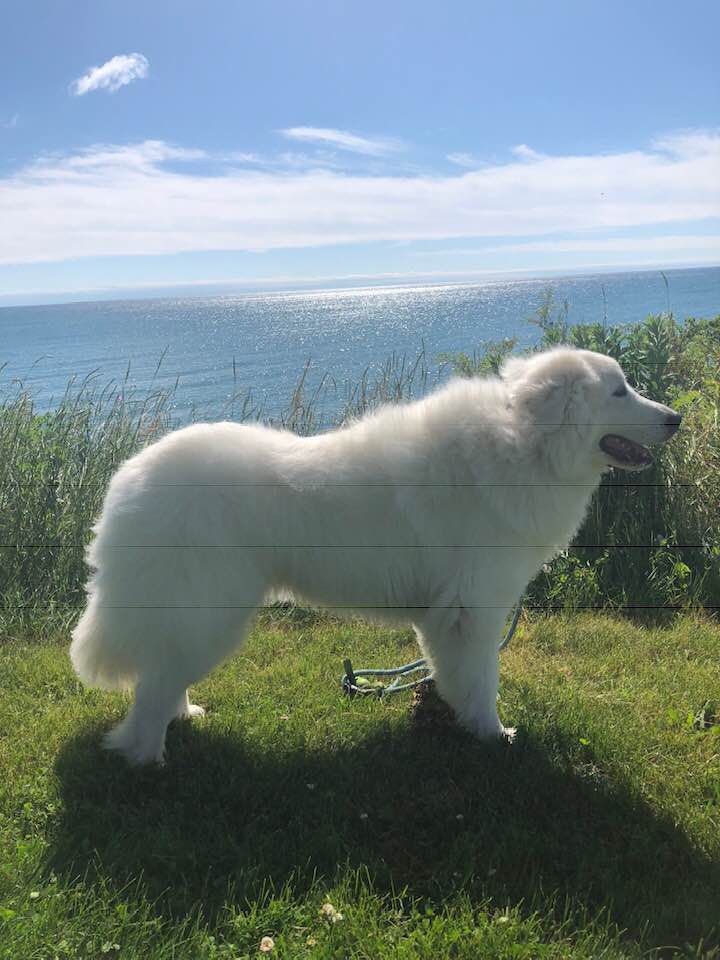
[0,375,171,628]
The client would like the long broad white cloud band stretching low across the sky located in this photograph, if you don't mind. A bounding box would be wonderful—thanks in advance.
[0,134,720,263]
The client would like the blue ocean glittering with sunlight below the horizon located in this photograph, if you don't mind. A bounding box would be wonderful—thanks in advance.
[0,267,720,423]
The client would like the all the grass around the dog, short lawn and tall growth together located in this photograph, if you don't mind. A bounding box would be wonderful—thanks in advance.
[0,295,720,960]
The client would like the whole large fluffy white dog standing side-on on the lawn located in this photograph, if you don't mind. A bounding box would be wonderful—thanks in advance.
[71,348,680,763]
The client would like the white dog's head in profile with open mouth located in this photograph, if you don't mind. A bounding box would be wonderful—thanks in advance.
[501,347,681,475]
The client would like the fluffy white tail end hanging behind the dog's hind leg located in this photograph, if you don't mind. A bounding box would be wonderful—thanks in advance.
[70,596,137,690]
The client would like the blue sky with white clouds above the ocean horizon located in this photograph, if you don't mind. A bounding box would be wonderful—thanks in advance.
[0,0,720,303]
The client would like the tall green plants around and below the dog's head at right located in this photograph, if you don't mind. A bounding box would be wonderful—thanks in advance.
[438,300,720,611]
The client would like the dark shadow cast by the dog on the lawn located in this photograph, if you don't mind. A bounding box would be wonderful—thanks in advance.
[48,704,720,947]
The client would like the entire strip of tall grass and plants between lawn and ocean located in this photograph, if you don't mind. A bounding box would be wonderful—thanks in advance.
[0,302,720,624]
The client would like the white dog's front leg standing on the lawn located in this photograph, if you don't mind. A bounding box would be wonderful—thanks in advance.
[417,607,515,740]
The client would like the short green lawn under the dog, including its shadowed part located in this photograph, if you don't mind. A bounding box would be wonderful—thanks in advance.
[0,614,720,960]
